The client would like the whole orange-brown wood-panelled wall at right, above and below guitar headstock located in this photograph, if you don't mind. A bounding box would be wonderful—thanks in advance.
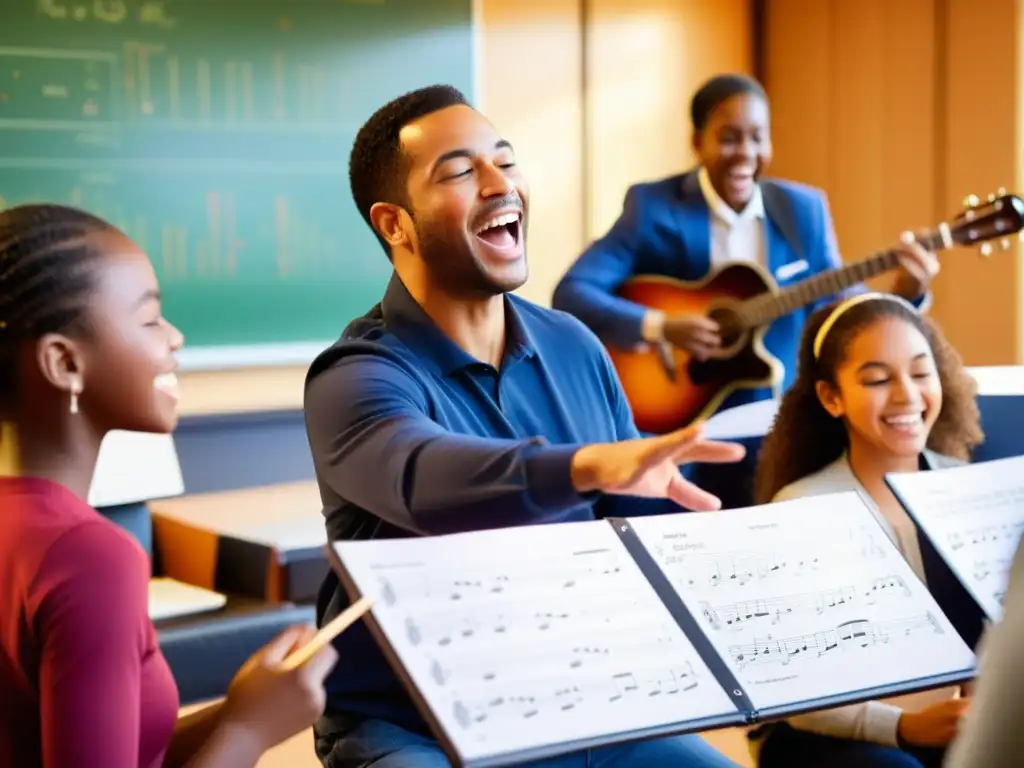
[765,0,1022,365]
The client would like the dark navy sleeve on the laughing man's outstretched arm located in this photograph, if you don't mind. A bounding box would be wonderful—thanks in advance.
[305,354,596,535]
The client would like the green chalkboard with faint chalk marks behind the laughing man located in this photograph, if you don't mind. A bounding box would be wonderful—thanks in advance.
[0,0,475,367]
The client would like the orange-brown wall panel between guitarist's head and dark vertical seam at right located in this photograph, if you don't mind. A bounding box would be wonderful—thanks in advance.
[764,0,937,268]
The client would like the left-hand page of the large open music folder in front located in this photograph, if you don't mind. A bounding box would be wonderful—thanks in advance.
[334,521,736,762]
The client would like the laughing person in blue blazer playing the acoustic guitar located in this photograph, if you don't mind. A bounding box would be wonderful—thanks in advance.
[552,75,938,501]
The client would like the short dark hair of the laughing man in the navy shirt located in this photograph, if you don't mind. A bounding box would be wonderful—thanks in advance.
[348,85,470,258]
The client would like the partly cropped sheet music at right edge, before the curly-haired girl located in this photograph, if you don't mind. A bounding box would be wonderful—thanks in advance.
[886,457,1024,622]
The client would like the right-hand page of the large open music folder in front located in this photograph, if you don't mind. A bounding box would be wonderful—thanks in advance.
[630,493,974,709]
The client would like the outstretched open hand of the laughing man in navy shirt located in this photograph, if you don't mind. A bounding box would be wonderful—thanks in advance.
[572,425,745,511]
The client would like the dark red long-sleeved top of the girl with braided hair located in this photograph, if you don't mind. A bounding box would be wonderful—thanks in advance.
[0,477,178,768]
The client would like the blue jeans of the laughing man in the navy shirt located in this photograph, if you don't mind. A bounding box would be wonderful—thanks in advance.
[314,714,738,768]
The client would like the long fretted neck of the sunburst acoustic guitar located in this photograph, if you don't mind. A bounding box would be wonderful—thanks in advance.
[740,227,946,328]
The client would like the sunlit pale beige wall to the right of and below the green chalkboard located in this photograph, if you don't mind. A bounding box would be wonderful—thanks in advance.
[176,0,752,414]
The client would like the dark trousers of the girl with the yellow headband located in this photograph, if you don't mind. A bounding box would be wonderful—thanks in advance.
[758,723,944,768]
